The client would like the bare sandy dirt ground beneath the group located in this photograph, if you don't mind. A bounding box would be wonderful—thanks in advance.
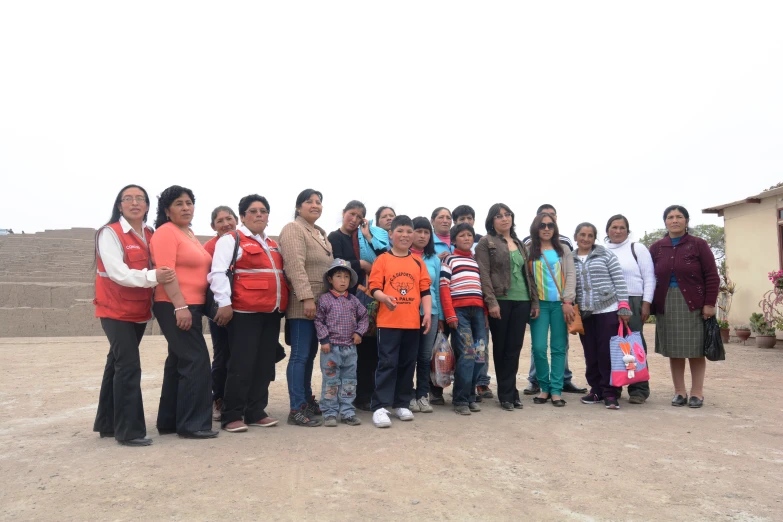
[0,328,783,521]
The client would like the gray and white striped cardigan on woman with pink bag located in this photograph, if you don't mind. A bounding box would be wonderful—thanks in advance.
[571,245,631,315]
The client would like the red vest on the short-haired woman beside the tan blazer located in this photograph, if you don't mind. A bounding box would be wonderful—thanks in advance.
[236,230,288,312]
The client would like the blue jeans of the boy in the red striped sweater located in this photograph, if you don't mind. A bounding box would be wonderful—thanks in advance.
[451,306,487,406]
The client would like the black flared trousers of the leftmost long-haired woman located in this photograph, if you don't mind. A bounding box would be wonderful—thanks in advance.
[92,317,147,440]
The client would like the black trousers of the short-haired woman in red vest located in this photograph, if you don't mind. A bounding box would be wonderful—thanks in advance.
[220,312,282,426]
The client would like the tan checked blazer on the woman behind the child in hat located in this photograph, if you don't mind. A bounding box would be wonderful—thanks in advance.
[279,217,332,319]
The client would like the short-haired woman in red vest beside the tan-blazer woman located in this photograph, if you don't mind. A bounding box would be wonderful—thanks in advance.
[209,194,288,433]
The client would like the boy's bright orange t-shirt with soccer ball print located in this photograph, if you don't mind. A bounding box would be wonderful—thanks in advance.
[370,250,431,329]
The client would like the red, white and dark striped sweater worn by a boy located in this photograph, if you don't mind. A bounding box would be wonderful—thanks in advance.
[440,250,484,322]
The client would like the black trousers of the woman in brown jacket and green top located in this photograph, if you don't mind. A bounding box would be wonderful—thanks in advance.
[489,300,531,402]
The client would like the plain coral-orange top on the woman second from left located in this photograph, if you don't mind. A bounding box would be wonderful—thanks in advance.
[150,223,212,305]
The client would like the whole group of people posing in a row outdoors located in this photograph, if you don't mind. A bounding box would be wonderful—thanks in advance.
[94,185,719,446]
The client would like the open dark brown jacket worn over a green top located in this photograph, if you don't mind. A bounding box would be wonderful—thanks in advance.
[476,234,539,309]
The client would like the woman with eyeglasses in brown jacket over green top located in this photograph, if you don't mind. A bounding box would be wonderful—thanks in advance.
[476,203,539,411]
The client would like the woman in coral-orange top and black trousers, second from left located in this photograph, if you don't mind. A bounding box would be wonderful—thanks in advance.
[150,185,218,439]
